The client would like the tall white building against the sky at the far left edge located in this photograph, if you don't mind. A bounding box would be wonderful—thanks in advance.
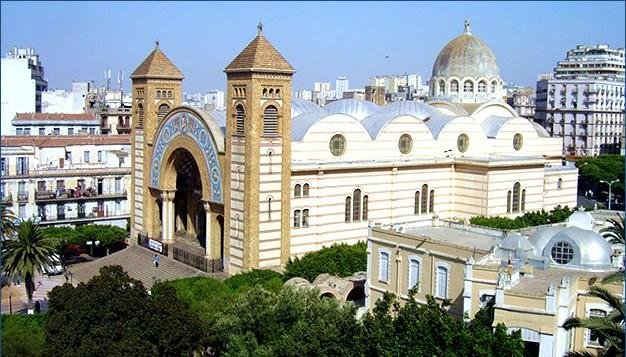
[0,47,48,134]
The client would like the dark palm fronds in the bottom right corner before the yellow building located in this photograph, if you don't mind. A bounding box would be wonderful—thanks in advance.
[563,285,624,357]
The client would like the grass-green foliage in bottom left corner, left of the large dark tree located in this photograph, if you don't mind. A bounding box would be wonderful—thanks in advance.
[0,314,45,357]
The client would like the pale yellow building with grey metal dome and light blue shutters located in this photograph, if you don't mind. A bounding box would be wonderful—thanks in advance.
[366,212,623,356]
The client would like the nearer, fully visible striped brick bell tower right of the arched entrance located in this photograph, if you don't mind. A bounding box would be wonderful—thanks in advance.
[224,24,295,274]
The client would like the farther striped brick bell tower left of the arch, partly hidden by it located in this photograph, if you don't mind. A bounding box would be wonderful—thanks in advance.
[130,41,183,242]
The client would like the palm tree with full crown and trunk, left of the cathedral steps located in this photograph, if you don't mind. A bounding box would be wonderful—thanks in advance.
[2,220,57,314]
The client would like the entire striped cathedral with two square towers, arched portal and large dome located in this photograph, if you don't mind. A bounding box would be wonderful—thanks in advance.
[131,23,578,274]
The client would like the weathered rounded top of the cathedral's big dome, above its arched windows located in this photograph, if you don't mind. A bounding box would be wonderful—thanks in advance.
[432,22,500,79]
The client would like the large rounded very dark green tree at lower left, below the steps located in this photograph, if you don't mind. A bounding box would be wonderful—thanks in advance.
[44,266,200,356]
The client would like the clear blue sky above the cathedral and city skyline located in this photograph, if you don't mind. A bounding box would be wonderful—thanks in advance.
[0,1,626,93]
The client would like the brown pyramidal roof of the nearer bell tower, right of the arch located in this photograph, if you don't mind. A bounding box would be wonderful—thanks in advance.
[224,24,295,73]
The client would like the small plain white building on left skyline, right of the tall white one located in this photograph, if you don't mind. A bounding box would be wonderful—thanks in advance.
[41,81,91,114]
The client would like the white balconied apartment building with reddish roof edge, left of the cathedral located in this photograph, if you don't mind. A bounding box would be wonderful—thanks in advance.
[0,134,130,228]
